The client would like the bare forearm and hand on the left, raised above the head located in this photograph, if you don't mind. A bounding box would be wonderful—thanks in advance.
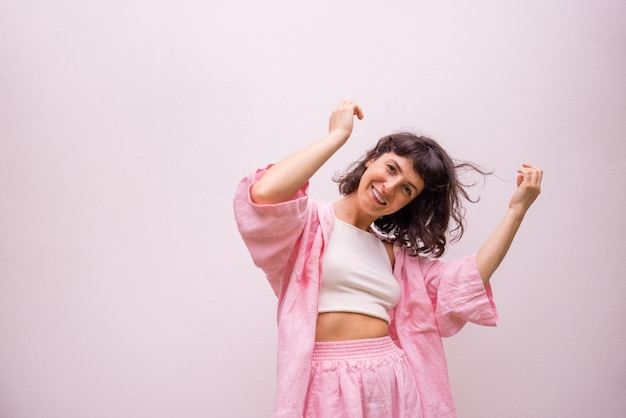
[250,100,363,204]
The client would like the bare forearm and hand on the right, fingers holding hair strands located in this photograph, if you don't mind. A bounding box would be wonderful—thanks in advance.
[476,164,543,283]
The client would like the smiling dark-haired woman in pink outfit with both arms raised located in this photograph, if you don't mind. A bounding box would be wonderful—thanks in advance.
[234,101,542,418]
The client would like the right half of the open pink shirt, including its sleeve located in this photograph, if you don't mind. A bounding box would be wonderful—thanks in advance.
[389,250,498,418]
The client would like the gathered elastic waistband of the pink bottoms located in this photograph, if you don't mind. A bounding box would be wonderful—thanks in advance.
[311,336,402,361]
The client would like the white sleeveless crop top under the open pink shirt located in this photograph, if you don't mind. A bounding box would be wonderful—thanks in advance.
[318,219,400,323]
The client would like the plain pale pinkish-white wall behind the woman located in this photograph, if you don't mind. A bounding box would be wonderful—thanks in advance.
[0,0,626,418]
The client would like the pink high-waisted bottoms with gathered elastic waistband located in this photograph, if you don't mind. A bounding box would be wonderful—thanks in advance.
[304,337,422,418]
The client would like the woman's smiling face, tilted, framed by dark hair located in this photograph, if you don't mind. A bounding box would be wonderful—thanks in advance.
[356,152,425,221]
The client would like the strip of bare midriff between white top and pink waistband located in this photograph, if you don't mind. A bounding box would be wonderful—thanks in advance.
[315,312,389,342]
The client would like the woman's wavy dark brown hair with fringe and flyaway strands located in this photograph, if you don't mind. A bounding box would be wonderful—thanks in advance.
[333,132,491,258]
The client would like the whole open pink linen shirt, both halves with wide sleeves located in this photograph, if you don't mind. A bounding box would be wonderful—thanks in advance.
[233,170,498,418]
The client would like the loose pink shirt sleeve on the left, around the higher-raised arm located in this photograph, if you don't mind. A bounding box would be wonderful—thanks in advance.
[233,165,309,296]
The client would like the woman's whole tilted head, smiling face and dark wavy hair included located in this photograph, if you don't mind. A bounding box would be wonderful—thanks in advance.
[334,132,460,257]
